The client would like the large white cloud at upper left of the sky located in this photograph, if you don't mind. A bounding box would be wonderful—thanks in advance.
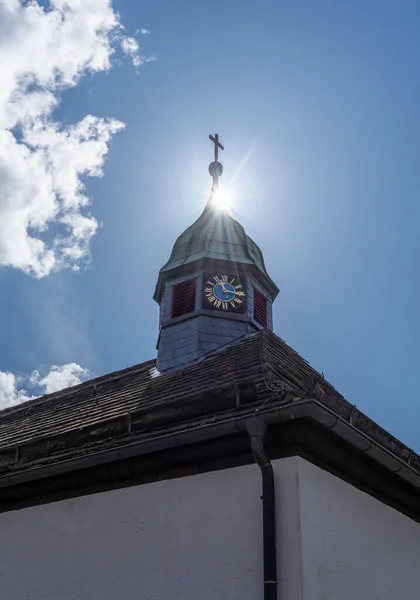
[0,0,148,277]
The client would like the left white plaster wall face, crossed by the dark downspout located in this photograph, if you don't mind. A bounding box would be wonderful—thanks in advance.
[0,459,300,600]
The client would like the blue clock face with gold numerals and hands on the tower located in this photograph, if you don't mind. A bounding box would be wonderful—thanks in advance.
[204,274,245,312]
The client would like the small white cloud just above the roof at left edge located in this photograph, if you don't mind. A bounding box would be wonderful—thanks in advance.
[0,363,89,410]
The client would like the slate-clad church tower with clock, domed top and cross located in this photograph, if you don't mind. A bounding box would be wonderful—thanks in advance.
[154,134,279,372]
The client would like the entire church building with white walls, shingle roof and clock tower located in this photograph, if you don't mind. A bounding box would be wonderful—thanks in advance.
[0,134,420,600]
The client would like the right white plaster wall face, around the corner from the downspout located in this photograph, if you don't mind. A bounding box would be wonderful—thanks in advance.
[298,459,420,600]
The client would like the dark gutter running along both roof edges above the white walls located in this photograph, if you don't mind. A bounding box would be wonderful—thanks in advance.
[0,399,420,490]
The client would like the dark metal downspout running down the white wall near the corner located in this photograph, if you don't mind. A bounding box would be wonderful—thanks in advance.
[247,415,277,600]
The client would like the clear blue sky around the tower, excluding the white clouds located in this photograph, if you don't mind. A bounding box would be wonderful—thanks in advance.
[0,0,420,451]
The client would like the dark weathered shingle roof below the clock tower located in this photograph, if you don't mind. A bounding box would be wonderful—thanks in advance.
[0,330,420,474]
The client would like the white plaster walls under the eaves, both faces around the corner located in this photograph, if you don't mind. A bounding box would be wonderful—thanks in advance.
[0,457,420,600]
